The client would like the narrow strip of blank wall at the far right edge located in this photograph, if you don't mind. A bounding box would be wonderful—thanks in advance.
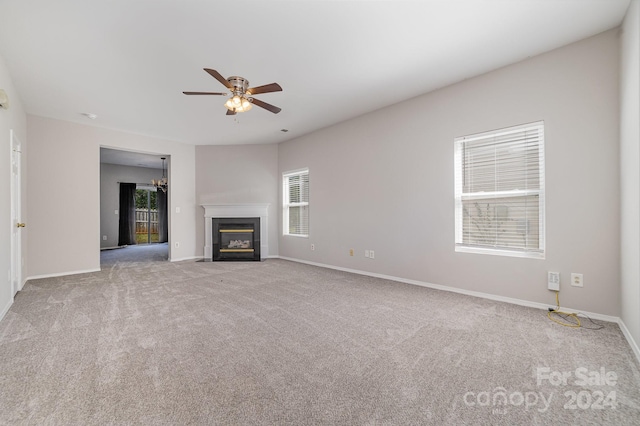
[620,0,640,350]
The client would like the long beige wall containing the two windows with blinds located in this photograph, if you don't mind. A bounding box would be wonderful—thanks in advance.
[278,30,620,316]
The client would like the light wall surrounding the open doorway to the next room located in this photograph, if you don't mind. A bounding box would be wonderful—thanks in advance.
[27,115,196,277]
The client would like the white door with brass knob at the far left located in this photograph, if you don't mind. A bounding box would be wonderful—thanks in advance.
[11,130,25,297]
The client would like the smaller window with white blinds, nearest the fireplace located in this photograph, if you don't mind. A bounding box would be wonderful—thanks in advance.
[282,169,309,237]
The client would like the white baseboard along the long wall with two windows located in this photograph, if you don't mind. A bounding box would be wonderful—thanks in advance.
[277,256,640,362]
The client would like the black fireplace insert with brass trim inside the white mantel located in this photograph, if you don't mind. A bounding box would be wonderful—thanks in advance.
[211,217,260,261]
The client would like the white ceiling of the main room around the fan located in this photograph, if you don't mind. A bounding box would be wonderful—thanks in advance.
[0,0,630,145]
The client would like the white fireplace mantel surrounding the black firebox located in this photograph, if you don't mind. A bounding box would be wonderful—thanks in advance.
[202,203,269,262]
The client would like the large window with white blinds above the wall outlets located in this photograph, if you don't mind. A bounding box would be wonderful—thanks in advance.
[455,121,545,258]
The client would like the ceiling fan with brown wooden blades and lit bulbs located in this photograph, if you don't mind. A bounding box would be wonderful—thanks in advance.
[182,68,282,115]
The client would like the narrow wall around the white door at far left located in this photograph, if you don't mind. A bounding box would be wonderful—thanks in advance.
[0,52,29,319]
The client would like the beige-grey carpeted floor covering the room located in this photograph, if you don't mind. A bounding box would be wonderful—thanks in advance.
[0,245,640,425]
